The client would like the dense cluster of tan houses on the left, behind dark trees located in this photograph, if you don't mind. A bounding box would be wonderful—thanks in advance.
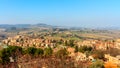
[2,35,56,48]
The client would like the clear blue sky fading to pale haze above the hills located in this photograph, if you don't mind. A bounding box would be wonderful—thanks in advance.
[0,0,120,27]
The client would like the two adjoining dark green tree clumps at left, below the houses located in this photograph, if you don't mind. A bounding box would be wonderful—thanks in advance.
[0,46,44,64]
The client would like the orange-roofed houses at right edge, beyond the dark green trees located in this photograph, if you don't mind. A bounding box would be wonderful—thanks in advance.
[77,39,120,50]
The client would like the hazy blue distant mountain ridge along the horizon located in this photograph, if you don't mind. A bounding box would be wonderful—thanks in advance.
[0,23,120,30]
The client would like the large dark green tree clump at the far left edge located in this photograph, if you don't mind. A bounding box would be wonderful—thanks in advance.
[0,46,22,64]
